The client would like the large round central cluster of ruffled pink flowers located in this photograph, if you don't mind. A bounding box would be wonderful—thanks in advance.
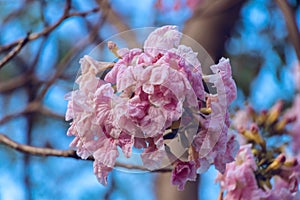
[66,26,238,190]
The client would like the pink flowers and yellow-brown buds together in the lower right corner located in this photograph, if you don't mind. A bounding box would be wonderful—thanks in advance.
[217,101,300,200]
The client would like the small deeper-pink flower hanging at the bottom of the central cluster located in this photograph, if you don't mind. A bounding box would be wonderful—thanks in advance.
[172,161,197,190]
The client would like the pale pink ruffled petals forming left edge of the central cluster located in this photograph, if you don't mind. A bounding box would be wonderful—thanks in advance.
[66,56,118,184]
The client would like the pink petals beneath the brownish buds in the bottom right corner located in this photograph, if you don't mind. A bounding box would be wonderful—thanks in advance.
[216,144,300,200]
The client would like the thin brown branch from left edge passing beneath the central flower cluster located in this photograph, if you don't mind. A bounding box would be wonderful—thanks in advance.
[0,133,171,172]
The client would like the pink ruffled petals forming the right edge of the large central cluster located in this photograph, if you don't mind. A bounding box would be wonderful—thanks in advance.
[193,59,239,173]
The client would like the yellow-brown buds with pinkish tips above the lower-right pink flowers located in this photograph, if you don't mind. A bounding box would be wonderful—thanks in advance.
[238,100,298,189]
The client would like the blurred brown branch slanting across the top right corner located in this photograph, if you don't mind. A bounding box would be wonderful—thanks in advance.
[275,0,300,61]
